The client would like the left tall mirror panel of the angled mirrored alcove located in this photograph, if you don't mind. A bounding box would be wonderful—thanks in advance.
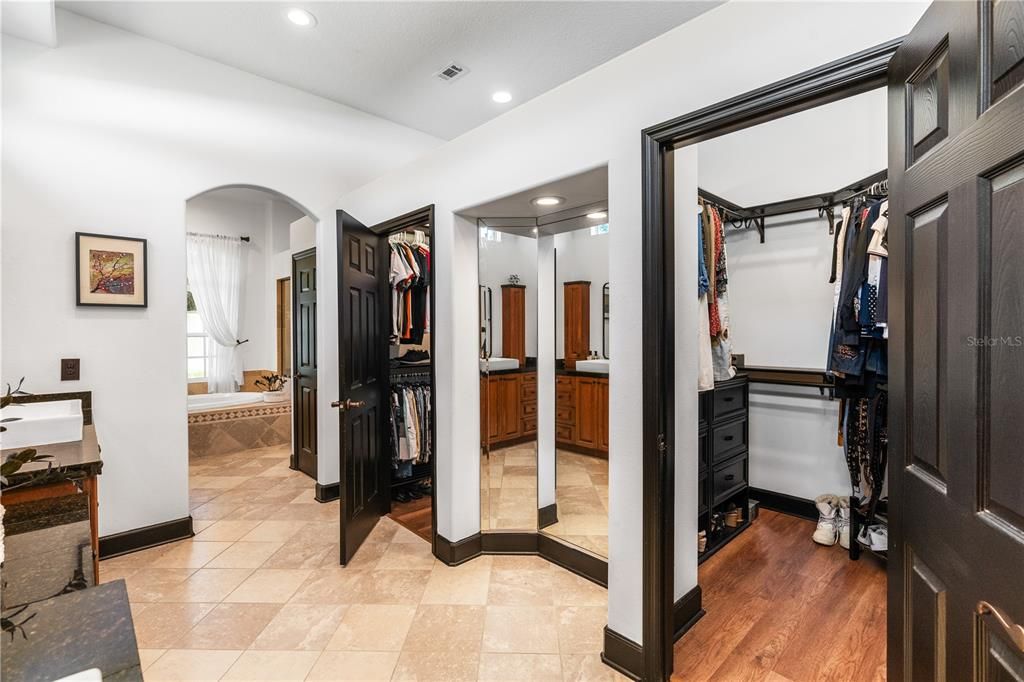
[478,224,537,530]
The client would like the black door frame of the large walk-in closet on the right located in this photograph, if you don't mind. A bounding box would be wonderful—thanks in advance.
[638,38,903,682]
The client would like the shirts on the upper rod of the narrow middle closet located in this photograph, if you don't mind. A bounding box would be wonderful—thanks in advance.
[388,230,431,345]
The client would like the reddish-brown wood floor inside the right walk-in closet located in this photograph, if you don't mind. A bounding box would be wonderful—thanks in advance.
[672,510,886,682]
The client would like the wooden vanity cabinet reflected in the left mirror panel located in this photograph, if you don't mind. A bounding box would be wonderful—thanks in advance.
[480,372,537,446]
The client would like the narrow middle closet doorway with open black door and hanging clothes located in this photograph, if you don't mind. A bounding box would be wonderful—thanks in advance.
[331,206,437,565]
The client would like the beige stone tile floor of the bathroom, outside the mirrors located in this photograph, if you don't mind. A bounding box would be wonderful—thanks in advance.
[100,447,625,682]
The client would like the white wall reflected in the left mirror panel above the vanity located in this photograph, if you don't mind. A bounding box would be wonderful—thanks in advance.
[479,232,537,357]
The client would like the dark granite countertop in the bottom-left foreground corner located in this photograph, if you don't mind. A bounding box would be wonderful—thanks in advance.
[2,580,142,682]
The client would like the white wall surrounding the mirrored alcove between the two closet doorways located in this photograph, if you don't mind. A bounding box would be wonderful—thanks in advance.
[333,2,926,642]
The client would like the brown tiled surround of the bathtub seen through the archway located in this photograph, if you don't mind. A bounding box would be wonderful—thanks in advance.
[188,402,290,456]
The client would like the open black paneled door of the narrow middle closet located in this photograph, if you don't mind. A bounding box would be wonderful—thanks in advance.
[333,211,390,564]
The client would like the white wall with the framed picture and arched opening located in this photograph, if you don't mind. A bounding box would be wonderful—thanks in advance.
[0,10,438,536]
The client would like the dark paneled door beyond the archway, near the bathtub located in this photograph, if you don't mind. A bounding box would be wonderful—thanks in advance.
[291,249,316,478]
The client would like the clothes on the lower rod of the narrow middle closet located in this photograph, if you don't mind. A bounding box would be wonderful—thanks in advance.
[388,380,433,478]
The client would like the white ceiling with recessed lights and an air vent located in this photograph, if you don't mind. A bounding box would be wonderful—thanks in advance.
[57,0,721,139]
